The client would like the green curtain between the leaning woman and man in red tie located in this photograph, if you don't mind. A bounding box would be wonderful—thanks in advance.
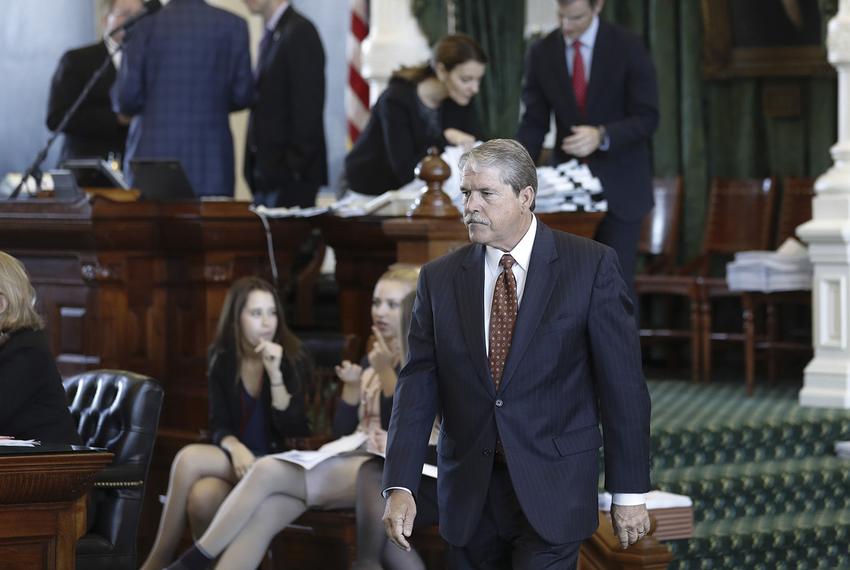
[455,0,525,139]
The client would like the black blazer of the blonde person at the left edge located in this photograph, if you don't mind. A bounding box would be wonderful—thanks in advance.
[0,329,80,445]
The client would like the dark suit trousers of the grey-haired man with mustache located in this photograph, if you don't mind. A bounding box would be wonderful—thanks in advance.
[449,463,581,570]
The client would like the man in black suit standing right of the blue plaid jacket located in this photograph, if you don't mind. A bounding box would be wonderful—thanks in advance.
[245,0,328,207]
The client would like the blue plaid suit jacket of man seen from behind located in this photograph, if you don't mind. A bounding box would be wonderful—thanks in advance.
[112,0,254,196]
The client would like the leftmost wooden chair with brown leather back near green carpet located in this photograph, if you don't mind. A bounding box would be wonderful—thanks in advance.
[635,177,700,379]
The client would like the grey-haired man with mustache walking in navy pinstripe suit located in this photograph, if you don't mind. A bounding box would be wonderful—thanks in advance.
[384,139,650,569]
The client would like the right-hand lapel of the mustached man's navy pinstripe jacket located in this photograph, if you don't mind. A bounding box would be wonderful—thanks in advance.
[500,220,558,390]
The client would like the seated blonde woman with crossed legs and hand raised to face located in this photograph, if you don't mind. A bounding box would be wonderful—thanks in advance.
[168,268,417,569]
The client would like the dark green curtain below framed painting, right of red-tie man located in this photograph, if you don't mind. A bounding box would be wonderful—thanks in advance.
[602,0,837,259]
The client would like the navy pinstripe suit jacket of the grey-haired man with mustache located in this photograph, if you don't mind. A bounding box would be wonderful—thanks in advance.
[384,222,650,546]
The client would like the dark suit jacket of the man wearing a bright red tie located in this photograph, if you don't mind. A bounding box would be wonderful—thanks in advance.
[517,20,658,221]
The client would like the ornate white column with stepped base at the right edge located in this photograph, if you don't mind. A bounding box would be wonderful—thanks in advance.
[797,0,850,408]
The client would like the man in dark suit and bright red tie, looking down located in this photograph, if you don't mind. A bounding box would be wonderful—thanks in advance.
[517,0,658,298]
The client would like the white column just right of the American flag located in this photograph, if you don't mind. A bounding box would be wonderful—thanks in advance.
[361,0,431,105]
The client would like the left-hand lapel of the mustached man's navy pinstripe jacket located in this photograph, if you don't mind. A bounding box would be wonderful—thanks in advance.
[455,245,495,394]
